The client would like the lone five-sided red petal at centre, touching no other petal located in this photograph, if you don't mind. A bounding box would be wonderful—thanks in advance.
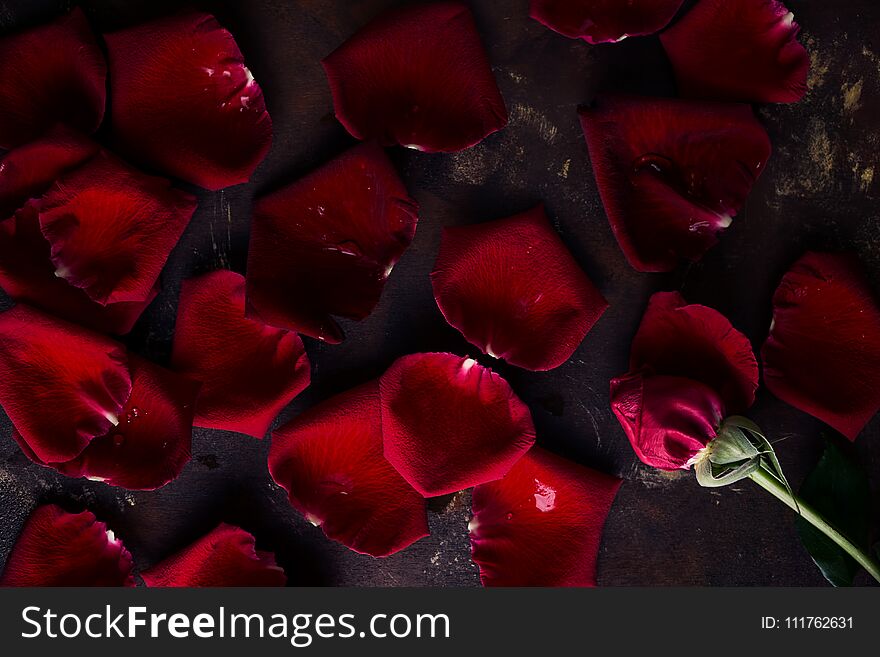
[431,206,608,370]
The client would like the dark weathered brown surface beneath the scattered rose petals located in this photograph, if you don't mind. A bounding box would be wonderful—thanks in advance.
[0,0,880,586]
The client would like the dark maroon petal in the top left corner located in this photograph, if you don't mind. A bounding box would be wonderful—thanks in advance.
[0,8,107,148]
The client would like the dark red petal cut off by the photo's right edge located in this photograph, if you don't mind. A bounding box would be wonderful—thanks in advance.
[761,253,880,440]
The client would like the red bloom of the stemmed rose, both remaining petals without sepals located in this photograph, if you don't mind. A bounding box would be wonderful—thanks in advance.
[611,292,758,470]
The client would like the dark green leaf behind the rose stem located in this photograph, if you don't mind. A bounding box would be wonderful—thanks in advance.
[796,442,871,586]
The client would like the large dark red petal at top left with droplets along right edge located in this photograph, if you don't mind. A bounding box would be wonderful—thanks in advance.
[105,12,272,189]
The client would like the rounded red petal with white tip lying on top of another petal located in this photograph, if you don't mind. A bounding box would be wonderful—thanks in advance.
[380,354,535,497]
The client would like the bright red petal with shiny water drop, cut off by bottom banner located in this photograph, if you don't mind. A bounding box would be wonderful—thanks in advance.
[468,447,621,586]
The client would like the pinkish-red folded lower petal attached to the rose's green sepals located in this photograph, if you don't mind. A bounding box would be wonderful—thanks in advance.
[611,372,725,470]
